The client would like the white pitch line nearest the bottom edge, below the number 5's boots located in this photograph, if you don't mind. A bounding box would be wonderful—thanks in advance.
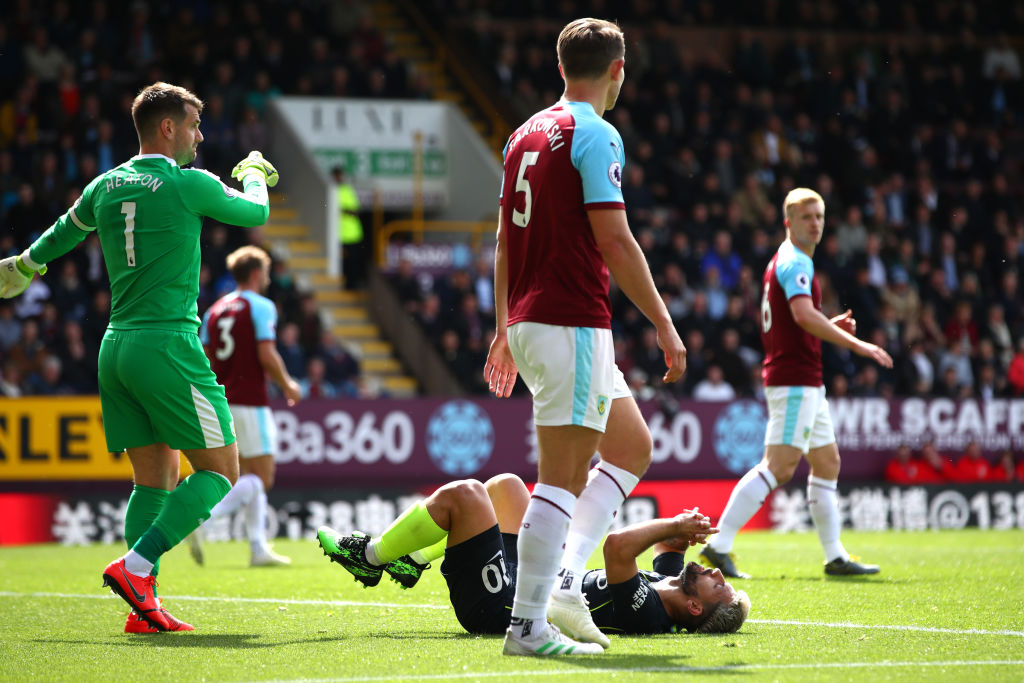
[251,659,1024,683]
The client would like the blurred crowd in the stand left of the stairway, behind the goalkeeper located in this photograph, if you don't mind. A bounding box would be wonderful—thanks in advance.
[0,0,409,396]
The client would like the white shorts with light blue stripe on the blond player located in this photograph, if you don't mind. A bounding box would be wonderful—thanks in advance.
[765,386,836,455]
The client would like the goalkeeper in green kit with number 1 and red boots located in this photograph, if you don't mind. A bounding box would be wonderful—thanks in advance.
[0,83,278,633]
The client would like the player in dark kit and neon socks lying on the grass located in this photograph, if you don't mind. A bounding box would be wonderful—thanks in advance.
[316,474,751,654]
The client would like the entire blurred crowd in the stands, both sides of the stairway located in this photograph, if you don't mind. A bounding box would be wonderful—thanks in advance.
[0,0,1024,411]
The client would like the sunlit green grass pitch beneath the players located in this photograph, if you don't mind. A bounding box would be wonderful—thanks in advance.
[0,530,1024,683]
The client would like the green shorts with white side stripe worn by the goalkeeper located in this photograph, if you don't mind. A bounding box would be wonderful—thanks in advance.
[99,329,234,453]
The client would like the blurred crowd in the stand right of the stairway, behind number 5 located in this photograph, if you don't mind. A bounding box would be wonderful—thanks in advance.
[385,0,1024,400]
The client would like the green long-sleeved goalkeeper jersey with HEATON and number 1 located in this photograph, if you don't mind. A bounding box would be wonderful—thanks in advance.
[29,155,269,332]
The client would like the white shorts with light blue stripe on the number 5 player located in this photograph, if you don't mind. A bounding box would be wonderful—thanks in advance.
[508,323,632,432]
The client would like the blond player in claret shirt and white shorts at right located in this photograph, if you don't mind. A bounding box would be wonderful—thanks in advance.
[700,187,893,579]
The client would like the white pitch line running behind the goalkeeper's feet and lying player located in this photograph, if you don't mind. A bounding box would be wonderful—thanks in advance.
[0,591,1024,638]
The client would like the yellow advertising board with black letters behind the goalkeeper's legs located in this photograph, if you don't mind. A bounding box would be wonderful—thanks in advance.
[0,396,186,481]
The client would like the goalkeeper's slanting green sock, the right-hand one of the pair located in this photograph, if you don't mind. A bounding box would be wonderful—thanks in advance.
[132,470,231,563]
